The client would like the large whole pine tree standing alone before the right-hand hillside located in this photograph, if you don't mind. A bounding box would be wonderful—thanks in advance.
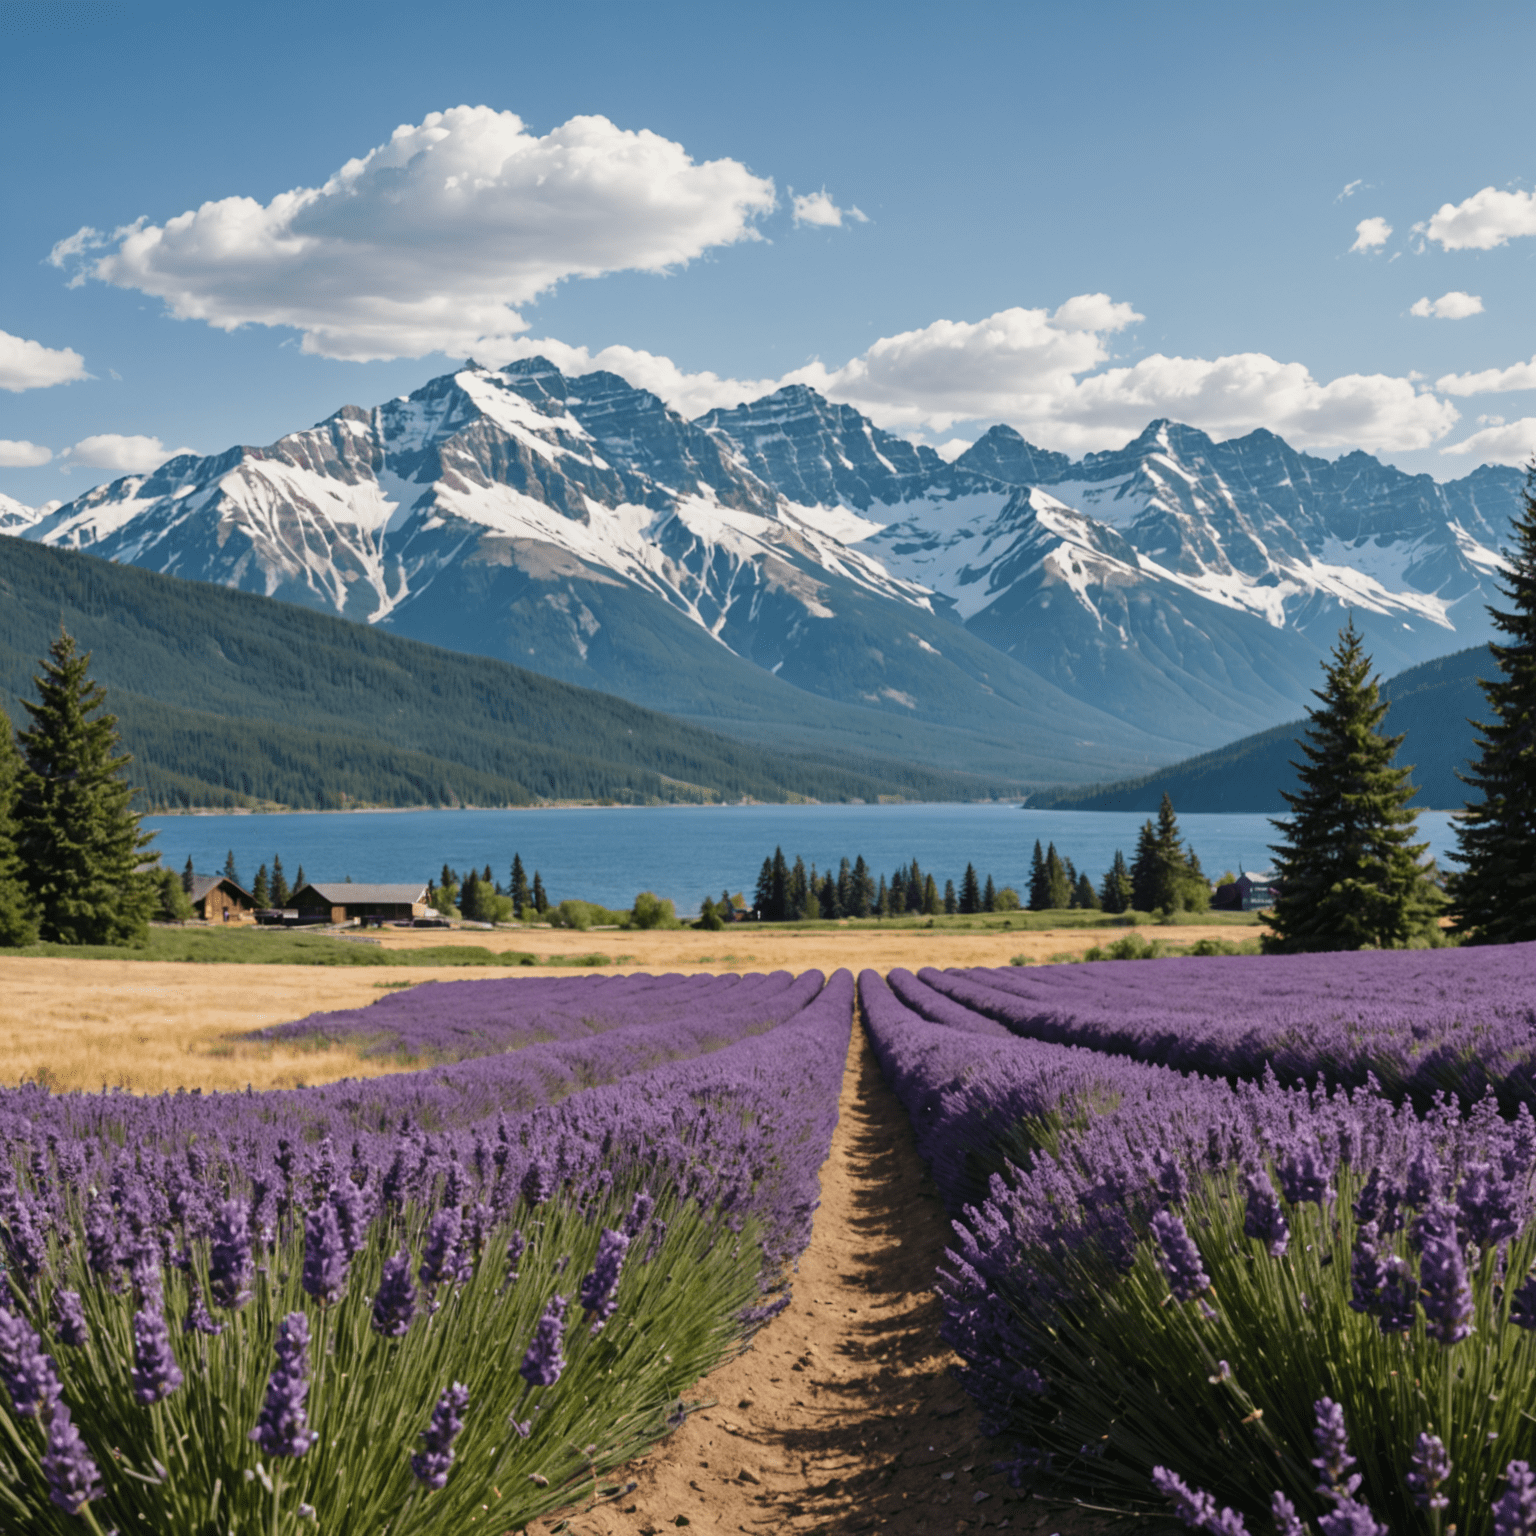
[1264,619,1441,954]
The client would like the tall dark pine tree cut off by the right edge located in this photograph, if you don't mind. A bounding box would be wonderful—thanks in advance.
[1450,464,1536,945]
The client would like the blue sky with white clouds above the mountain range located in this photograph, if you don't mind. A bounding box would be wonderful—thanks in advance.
[0,0,1536,505]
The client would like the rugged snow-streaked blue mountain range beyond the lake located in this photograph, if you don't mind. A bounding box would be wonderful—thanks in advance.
[0,358,1522,783]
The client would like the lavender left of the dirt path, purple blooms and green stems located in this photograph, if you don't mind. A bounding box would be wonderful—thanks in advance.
[0,972,852,1536]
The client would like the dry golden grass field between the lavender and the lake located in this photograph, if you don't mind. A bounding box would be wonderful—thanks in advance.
[0,923,1247,1094]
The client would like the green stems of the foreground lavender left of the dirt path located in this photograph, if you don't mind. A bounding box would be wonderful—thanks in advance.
[0,1186,762,1536]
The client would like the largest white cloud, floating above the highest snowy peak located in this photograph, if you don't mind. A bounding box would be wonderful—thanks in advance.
[49,106,777,359]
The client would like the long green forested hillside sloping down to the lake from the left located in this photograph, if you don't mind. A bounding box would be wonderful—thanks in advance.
[0,539,1017,808]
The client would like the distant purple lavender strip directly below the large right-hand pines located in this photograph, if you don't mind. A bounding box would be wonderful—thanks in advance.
[919,943,1536,1112]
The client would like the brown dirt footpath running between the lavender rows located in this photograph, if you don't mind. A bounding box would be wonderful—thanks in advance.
[540,1025,1097,1536]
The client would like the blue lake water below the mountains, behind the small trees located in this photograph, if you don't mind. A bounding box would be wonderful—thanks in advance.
[144,805,1455,911]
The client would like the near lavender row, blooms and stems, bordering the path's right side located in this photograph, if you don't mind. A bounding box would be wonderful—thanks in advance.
[859,957,1536,1536]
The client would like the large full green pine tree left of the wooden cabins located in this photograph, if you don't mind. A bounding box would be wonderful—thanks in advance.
[14,631,155,945]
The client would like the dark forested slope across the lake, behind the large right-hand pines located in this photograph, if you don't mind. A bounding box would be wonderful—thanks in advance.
[1029,645,1495,811]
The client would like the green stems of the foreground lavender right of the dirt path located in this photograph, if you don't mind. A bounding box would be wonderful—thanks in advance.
[1009,1161,1536,1536]
